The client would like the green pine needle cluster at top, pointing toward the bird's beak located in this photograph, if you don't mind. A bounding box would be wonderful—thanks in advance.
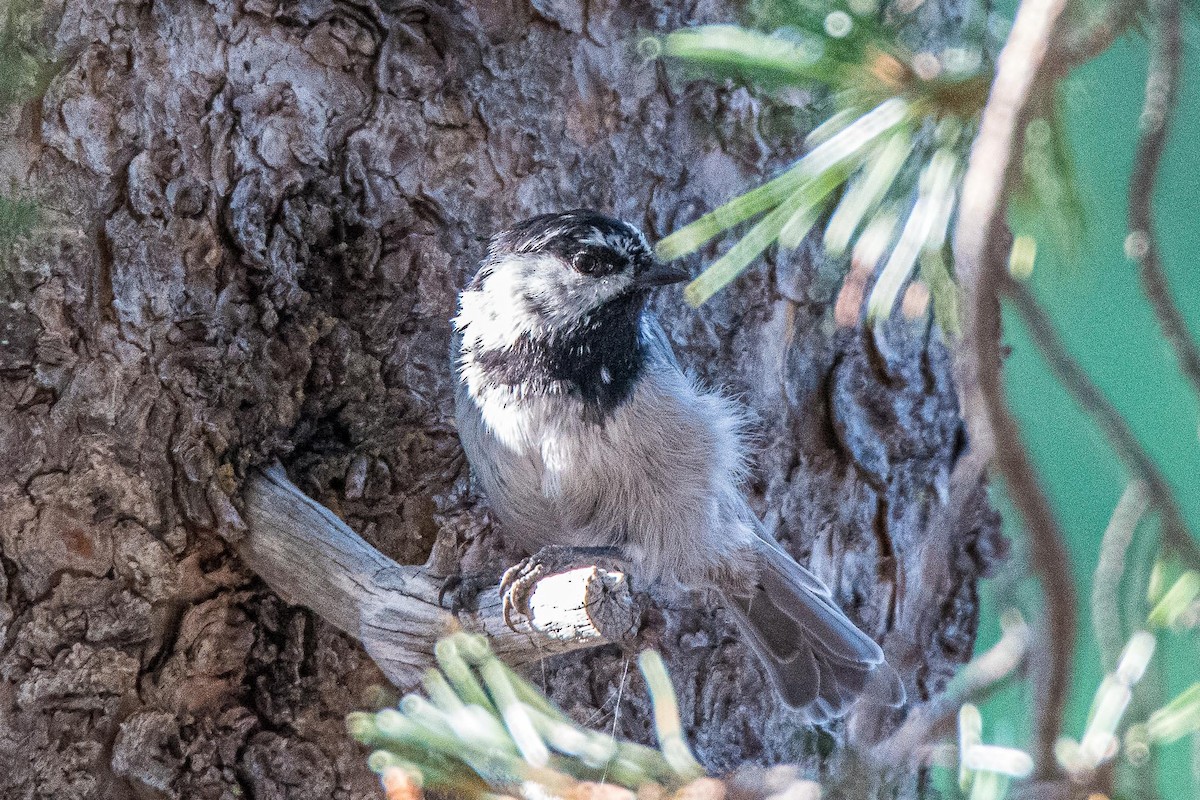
[647,0,1081,332]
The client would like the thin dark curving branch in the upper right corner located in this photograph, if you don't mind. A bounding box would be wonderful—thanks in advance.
[1126,0,1200,407]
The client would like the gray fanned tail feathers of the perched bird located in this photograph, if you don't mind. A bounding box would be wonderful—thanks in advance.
[725,540,904,722]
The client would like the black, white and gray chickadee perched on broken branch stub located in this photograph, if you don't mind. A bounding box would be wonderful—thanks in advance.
[451,209,902,722]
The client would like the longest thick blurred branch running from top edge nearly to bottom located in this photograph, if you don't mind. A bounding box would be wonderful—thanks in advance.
[954,0,1078,777]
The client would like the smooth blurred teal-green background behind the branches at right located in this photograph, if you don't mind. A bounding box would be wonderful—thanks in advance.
[977,28,1200,799]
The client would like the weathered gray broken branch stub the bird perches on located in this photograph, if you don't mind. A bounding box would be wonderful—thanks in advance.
[235,464,637,687]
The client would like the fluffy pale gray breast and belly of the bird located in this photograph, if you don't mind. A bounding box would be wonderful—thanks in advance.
[458,352,745,579]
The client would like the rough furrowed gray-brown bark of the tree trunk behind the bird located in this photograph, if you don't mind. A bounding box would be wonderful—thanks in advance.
[0,0,998,800]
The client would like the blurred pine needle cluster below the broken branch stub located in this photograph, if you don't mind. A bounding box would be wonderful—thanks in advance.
[346,633,704,796]
